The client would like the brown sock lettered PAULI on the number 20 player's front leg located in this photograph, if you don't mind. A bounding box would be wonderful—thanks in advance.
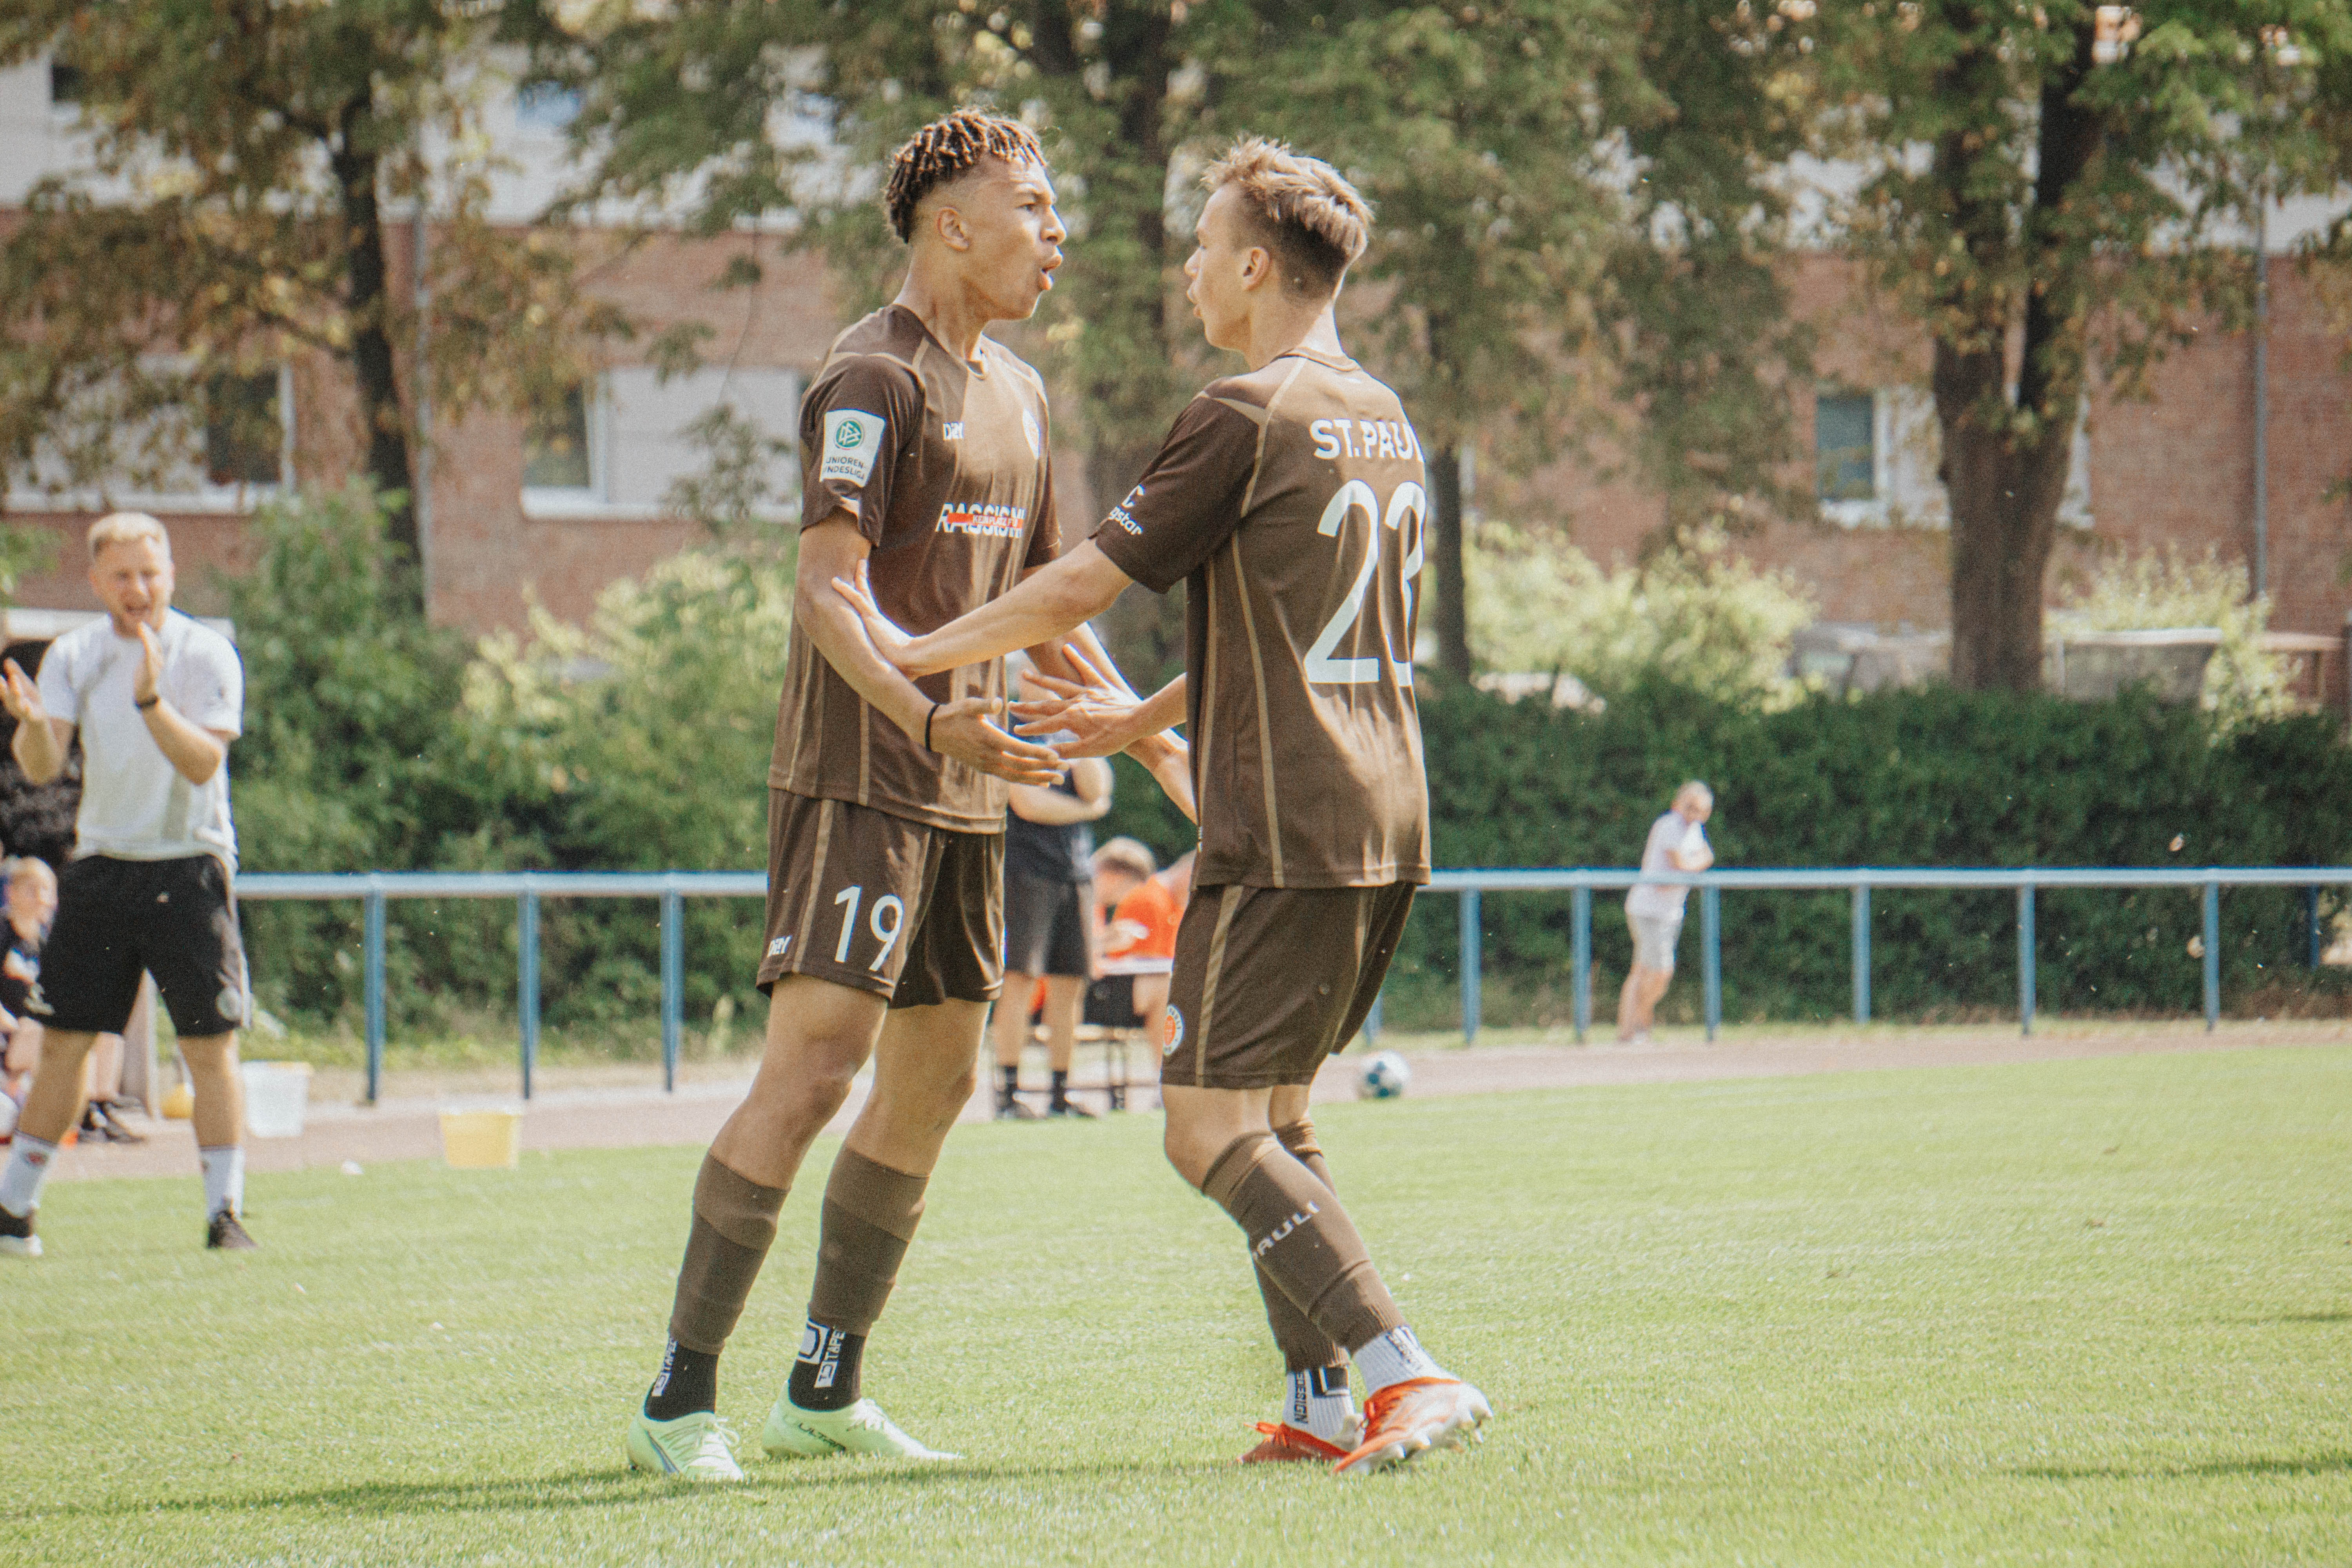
[1200,1133,1404,1345]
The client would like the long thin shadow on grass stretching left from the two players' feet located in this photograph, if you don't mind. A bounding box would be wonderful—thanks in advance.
[0,1460,1230,1523]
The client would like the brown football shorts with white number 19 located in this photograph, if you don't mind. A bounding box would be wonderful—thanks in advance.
[760,790,1004,1009]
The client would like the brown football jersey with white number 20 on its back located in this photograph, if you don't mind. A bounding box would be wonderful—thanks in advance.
[1094,348,1430,889]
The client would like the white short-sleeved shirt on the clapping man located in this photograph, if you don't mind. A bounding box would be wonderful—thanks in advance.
[40,609,245,870]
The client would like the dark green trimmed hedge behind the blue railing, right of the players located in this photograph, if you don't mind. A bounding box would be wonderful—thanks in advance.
[1110,686,2352,1025]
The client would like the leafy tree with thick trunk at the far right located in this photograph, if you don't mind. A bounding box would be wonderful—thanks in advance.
[1797,0,2352,691]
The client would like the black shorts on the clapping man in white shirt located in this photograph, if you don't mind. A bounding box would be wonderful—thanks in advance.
[26,856,254,1039]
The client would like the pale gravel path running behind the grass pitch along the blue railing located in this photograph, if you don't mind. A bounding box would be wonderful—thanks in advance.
[56,1020,2352,1180]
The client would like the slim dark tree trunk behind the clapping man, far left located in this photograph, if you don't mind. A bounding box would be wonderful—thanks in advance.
[332,99,423,613]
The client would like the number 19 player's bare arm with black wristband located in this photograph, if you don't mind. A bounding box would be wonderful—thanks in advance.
[793,512,1061,785]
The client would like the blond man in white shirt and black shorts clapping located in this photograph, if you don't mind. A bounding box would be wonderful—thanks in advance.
[0,512,254,1258]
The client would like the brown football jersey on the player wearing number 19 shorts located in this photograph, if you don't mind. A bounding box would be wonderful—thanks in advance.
[767,306,1061,832]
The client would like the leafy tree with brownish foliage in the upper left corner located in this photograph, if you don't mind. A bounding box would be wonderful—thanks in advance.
[0,0,621,588]
